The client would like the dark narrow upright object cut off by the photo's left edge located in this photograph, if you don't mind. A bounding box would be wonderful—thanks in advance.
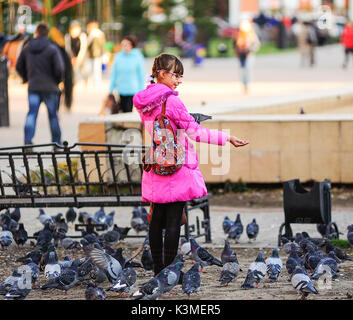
[0,56,10,127]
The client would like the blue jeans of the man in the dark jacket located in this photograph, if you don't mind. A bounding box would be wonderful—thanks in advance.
[25,92,61,145]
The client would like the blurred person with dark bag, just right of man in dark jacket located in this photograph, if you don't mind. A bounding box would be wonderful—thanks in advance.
[65,21,88,84]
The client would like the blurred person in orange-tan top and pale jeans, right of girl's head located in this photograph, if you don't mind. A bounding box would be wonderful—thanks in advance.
[235,20,260,93]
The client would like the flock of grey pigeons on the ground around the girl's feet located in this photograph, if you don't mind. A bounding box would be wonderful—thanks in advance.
[0,207,353,300]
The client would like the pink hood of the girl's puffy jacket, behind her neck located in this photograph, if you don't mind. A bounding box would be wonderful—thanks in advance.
[133,83,179,114]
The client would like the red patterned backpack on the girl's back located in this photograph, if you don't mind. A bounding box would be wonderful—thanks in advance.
[142,101,185,176]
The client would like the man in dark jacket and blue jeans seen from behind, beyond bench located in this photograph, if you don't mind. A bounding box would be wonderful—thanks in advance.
[16,22,65,145]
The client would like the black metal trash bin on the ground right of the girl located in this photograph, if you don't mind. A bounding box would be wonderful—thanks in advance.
[278,179,339,246]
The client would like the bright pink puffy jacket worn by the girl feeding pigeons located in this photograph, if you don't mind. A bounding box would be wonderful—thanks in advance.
[133,83,228,203]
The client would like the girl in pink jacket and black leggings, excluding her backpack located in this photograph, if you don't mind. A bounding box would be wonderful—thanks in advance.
[133,54,249,274]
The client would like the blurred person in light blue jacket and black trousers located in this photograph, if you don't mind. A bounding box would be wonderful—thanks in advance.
[109,35,145,112]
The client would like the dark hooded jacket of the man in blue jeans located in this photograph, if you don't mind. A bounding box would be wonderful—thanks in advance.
[16,37,65,92]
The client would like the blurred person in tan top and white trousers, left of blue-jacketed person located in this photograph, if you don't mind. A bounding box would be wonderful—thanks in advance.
[87,21,105,86]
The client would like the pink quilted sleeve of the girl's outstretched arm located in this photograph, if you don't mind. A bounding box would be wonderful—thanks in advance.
[166,97,229,146]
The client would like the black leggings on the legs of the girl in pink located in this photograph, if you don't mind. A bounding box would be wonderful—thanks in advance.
[149,202,185,274]
